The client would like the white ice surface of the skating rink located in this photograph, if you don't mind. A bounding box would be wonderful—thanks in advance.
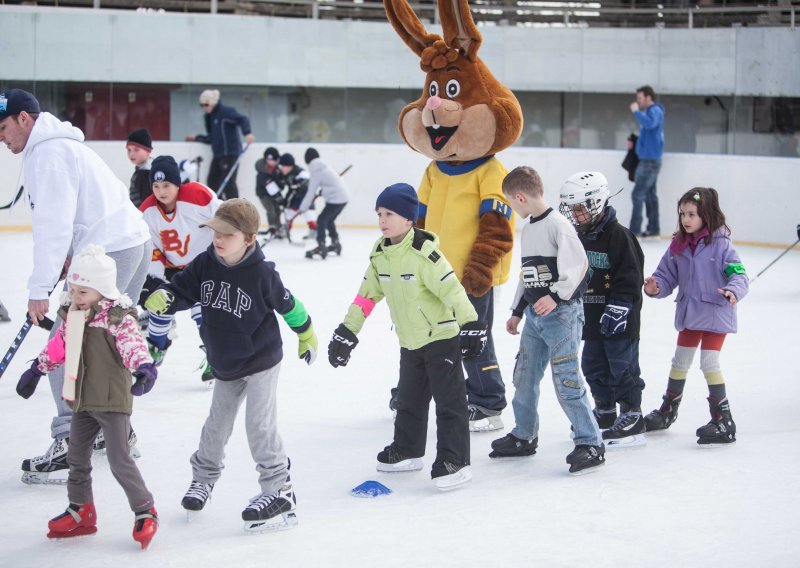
[0,227,800,568]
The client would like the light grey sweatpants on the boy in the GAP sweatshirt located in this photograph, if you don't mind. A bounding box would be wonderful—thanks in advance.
[189,363,287,495]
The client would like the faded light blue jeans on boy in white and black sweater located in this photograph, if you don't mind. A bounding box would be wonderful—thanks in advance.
[511,300,603,446]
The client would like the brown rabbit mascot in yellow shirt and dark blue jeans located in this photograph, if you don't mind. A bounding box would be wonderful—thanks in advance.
[384,0,522,431]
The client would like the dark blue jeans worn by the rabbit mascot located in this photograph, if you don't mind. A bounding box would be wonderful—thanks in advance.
[464,288,506,411]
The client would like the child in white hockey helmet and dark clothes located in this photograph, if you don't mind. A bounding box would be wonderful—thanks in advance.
[559,172,645,450]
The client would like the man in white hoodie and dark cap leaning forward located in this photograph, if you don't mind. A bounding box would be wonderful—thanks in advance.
[0,89,152,482]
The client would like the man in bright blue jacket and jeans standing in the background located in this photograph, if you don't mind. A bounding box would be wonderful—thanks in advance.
[628,85,664,237]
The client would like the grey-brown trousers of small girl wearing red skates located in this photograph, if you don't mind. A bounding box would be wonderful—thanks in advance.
[67,411,153,513]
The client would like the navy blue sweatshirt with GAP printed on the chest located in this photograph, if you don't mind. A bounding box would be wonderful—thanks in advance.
[162,245,311,381]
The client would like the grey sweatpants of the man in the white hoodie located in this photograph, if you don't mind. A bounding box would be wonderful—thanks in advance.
[48,241,153,438]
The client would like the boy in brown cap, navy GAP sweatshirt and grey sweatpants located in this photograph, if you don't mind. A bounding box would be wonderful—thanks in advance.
[145,198,317,532]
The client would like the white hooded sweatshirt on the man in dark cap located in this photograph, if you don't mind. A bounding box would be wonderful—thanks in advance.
[22,112,150,300]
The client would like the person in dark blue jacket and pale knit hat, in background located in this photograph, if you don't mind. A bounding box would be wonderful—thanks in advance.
[186,89,256,199]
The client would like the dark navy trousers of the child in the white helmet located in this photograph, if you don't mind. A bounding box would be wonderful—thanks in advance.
[581,336,644,408]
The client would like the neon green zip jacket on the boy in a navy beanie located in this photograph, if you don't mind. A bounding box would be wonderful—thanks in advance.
[344,229,478,349]
